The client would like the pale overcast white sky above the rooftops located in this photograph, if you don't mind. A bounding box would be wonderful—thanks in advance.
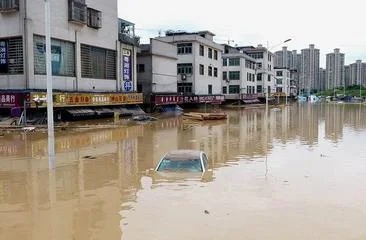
[118,0,366,68]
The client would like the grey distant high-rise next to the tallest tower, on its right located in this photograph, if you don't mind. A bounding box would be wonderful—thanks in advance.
[325,48,345,89]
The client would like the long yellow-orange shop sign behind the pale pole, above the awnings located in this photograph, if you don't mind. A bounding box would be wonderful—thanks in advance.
[30,92,143,108]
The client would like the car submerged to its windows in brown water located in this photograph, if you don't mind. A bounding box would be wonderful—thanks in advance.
[155,150,208,172]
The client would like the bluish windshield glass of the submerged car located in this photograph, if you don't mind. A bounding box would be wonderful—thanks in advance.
[158,159,202,172]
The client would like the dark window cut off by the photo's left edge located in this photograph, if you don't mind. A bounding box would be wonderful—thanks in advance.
[0,37,24,74]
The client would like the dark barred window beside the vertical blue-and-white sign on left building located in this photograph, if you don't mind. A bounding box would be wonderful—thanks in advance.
[81,44,116,79]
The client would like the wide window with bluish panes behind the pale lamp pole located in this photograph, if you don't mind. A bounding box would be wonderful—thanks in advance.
[33,35,75,77]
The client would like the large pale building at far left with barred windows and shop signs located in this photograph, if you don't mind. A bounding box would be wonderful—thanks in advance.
[0,0,142,114]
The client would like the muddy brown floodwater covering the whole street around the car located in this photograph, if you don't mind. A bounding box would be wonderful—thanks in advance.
[0,103,366,240]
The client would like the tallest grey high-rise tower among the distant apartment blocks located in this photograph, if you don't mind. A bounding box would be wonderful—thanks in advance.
[299,44,320,94]
